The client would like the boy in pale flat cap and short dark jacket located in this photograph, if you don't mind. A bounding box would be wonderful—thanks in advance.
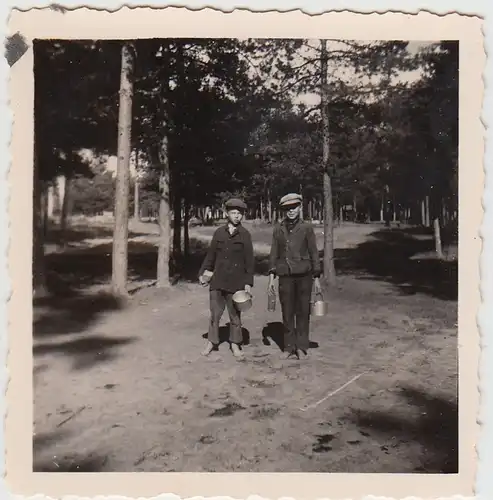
[269,193,321,359]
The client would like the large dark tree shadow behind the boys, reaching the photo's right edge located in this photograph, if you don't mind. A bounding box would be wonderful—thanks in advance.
[330,229,458,300]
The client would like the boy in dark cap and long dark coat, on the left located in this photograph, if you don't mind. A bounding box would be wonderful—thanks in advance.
[199,198,255,359]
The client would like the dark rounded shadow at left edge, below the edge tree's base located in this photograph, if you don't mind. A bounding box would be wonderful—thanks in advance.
[33,292,125,337]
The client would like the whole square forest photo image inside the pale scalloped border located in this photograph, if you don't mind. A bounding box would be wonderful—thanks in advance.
[4,9,479,493]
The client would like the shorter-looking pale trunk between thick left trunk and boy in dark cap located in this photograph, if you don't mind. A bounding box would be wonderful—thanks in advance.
[160,132,173,288]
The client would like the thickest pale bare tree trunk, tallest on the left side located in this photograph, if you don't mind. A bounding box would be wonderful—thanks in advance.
[111,42,134,295]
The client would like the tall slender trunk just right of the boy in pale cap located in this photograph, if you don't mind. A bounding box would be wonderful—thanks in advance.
[320,40,336,288]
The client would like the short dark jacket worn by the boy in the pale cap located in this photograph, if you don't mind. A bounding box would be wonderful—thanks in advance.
[269,220,321,277]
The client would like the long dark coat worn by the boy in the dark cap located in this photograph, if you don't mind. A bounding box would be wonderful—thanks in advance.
[199,225,255,293]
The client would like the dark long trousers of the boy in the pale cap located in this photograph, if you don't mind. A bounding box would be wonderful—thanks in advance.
[279,275,313,351]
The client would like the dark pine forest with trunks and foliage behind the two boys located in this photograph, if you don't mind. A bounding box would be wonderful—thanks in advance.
[33,39,458,294]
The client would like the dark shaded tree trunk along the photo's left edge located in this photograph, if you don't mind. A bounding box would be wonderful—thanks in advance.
[32,133,47,298]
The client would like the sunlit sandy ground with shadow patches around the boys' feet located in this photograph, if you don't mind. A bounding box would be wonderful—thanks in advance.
[34,223,457,472]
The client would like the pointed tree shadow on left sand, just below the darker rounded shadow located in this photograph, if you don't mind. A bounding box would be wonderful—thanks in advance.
[33,335,136,370]
